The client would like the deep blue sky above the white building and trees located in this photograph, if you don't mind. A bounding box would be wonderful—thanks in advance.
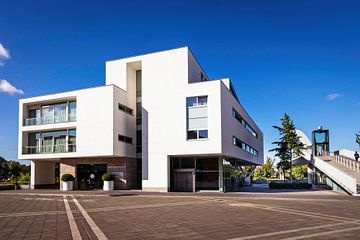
[0,0,360,164]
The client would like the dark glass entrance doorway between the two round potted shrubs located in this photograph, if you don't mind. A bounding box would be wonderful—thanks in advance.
[76,164,107,190]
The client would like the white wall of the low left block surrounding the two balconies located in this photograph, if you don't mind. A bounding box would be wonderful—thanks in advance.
[18,85,135,160]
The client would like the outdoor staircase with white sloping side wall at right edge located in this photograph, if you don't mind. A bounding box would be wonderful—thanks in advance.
[297,130,360,196]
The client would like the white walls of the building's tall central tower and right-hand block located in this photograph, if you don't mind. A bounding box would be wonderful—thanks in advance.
[106,47,263,190]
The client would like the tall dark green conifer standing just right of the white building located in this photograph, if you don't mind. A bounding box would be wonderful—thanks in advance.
[270,113,304,182]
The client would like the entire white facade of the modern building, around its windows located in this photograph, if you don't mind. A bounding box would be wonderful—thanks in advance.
[19,47,263,191]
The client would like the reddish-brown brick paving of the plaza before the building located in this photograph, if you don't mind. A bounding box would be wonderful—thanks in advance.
[0,190,360,240]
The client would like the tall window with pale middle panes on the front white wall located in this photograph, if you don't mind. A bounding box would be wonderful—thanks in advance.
[186,96,208,140]
